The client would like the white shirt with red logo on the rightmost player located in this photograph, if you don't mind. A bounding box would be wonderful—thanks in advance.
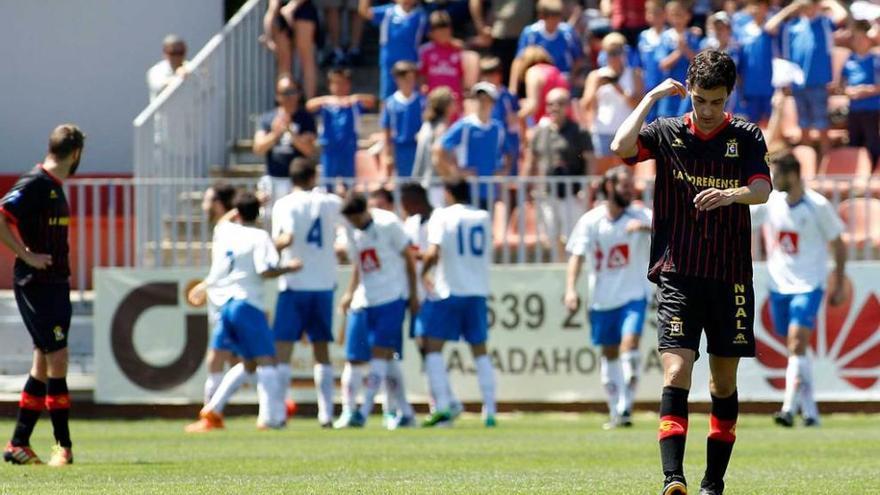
[751,189,844,294]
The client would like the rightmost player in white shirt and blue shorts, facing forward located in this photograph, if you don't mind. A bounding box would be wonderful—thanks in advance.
[751,154,846,427]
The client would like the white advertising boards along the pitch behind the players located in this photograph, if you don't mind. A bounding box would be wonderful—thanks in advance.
[95,262,880,403]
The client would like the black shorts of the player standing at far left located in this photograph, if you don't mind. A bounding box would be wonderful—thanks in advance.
[14,282,73,354]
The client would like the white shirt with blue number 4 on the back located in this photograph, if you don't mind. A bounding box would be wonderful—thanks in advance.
[272,189,342,291]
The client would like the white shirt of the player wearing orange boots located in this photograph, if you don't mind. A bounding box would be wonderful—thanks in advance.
[205,222,279,308]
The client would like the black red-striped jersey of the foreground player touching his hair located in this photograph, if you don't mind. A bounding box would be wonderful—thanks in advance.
[627,114,770,283]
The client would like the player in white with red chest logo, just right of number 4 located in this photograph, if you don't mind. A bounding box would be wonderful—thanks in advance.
[334,193,419,429]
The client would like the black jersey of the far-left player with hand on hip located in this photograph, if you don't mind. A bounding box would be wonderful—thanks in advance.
[0,165,70,284]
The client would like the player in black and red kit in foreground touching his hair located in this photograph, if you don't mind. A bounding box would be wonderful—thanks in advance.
[611,50,771,495]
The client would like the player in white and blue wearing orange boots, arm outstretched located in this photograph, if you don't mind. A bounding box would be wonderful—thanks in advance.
[187,193,302,432]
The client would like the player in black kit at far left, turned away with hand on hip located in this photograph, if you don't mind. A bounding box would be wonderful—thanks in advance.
[0,124,85,466]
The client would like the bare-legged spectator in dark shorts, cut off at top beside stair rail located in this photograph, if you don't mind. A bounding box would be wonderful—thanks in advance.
[263,0,318,98]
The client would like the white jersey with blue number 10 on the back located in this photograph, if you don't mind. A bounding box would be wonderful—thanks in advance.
[428,204,493,299]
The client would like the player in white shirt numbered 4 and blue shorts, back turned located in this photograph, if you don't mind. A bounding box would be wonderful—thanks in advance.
[272,157,342,428]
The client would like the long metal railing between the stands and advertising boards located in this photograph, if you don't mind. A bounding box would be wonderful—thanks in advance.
[65,177,880,302]
